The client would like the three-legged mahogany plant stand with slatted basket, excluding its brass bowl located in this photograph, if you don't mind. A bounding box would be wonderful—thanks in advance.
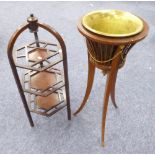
[74,19,148,146]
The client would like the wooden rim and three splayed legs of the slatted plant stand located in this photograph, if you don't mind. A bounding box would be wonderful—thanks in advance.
[74,18,149,146]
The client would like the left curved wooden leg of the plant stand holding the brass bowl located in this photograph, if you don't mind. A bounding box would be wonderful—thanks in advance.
[74,61,95,115]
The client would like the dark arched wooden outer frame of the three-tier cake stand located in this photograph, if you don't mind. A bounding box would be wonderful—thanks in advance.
[7,15,71,127]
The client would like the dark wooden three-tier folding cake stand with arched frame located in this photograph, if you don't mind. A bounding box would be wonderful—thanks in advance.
[7,14,71,126]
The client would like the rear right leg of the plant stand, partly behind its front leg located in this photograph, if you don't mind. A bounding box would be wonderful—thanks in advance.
[111,69,118,108]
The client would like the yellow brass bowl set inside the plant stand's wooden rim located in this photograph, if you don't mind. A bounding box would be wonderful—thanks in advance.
[82,10,143,37]
